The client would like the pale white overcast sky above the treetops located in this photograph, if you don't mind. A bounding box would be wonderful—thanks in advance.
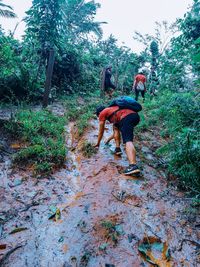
[0,0,193,52]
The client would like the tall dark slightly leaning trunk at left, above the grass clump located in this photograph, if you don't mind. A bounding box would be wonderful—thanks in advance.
[43,49,55,108]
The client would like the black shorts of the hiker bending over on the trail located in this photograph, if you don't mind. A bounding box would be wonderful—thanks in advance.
[115,113,140,144]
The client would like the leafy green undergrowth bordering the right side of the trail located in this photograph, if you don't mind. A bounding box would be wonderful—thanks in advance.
[139,91,200,197]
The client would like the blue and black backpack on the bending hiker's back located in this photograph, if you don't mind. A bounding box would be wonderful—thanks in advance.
[108,96,142,120]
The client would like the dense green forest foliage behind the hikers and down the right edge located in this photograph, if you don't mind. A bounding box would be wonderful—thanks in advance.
[0,0,200,195]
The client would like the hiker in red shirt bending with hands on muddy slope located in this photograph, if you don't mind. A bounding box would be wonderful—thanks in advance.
[95,96,142,175]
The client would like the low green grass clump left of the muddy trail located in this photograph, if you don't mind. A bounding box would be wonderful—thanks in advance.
[5,110,66,174]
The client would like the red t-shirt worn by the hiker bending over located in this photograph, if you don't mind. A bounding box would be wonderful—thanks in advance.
[99,106,136,123]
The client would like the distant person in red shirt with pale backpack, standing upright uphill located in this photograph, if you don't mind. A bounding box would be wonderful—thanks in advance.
[133,71,147,102]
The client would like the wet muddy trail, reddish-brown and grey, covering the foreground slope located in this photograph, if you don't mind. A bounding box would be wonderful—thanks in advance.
[0,110,200,267]
